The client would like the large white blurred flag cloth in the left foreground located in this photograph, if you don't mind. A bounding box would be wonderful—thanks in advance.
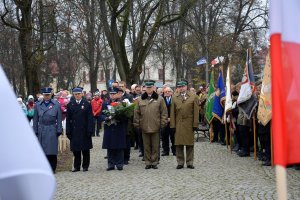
[0,65,56,200]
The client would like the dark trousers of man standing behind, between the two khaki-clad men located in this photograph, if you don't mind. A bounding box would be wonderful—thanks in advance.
[162,124,176,154]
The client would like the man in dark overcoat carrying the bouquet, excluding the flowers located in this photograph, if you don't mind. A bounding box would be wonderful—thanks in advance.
[101,88,128,171]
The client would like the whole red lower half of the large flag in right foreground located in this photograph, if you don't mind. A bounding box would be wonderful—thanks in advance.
[271,34,300,166]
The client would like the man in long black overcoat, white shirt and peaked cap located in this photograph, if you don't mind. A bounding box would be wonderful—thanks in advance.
[66,87,94,172]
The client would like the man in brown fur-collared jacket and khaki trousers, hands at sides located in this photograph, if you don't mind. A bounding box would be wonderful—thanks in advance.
[133,80,168,169]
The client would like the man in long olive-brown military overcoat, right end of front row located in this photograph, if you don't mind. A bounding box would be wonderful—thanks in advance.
[170,80,199,169]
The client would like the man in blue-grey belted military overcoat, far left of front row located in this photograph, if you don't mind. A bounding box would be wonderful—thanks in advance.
[33,88,62,173]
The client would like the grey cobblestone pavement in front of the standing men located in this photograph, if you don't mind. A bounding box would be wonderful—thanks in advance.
[55,134,300,200]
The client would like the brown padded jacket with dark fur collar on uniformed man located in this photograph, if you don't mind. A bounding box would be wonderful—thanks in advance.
[133,93,168,133]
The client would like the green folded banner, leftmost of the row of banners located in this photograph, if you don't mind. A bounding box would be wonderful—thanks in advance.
[205,70,215,124]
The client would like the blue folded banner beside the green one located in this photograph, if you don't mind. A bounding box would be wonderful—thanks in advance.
[212,70,226,121]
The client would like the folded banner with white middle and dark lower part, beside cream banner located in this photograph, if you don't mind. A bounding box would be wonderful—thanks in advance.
[237,50,257,119]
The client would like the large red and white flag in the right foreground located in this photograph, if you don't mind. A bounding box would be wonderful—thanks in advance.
[270,0,300,166]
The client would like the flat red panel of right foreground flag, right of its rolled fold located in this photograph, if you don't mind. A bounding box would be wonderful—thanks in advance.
[282,42,300,164]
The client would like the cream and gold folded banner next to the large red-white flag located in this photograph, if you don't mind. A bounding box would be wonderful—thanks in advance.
[257,53,272,126]
